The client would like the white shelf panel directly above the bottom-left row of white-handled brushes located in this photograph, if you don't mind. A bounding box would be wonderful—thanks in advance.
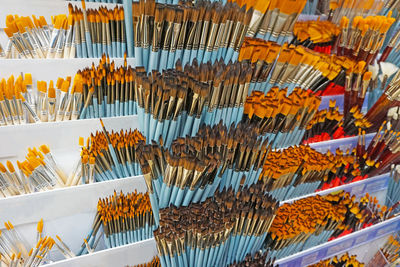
[0,176,147,260]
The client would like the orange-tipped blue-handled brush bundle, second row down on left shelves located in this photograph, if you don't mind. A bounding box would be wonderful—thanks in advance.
[74,55,137,119]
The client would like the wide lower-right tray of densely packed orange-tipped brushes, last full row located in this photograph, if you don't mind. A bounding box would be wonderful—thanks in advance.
[265,191,394,259]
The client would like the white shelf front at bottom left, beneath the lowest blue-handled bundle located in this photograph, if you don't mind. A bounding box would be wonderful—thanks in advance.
[44,238,157,267]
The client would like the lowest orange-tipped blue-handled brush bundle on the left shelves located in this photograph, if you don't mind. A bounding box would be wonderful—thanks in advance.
[77,191,156,255]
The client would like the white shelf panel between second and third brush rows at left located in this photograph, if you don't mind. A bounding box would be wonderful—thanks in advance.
[0,115,139,173]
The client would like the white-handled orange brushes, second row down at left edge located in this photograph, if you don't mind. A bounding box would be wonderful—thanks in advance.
[0,73,87,126]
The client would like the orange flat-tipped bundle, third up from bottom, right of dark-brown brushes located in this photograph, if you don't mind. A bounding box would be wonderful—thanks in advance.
[243,90,321,148]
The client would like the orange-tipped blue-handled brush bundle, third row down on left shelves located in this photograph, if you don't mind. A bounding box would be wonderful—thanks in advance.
[77,128,145,185]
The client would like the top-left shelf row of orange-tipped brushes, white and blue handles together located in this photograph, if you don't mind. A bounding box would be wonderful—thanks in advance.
[4,1,127,58]
